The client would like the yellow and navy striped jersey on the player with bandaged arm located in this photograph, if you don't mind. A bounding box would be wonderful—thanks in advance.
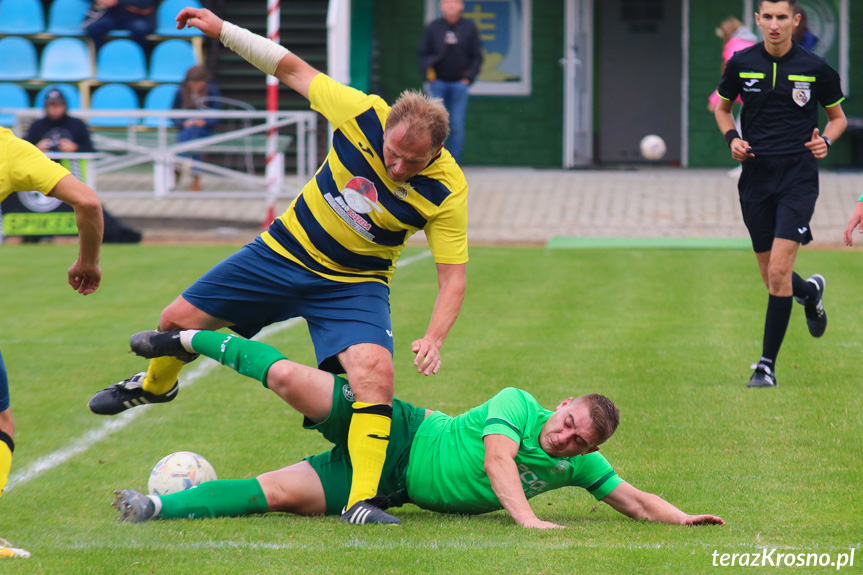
[261,74,468,284]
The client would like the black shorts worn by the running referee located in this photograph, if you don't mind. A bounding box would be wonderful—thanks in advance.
[737,150,818,253]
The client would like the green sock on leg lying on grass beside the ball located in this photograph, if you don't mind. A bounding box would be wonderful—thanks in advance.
[159,478,267,519]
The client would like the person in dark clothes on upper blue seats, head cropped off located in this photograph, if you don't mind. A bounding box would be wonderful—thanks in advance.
[82,0,158,50]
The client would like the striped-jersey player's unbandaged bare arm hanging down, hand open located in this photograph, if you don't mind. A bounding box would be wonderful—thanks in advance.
[411,264,467,375]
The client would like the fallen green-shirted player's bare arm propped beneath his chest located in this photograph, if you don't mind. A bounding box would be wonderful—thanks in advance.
[483,435,563,529]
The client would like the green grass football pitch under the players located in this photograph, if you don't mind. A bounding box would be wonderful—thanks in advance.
[0,245,863,574]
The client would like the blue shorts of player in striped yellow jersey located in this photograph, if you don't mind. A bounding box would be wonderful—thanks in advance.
[183,238,393,373]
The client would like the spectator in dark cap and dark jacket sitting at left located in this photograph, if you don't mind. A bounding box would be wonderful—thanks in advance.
[24,89,93,154]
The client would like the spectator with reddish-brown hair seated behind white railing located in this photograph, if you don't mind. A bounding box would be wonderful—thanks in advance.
[171,66,221,192]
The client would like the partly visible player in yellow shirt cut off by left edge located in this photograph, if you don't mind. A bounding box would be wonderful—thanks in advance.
[0,128,103,558]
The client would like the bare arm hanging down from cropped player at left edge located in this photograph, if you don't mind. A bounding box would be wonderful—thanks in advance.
[51,175,104,295]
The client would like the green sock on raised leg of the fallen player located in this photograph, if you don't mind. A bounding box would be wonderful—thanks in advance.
[192,331,288,387]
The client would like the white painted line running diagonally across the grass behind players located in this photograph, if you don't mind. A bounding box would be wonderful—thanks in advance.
[5,250,431,492]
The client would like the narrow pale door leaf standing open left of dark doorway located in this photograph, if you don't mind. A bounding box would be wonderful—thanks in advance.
[560,0,593,168]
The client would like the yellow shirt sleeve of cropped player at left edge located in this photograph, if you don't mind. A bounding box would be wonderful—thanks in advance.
[0,128,69,201]
